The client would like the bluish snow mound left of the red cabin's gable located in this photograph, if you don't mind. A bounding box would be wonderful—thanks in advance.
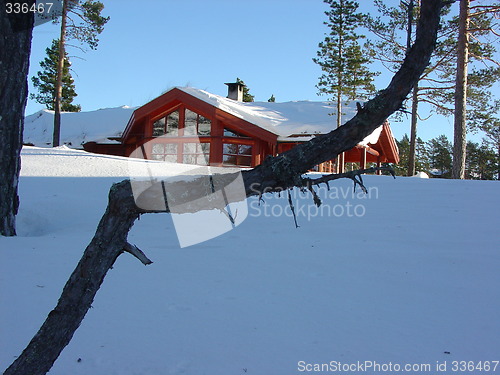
[23,106,135,148]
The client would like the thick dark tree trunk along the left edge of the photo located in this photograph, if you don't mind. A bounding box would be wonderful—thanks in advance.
[0,0,34,236]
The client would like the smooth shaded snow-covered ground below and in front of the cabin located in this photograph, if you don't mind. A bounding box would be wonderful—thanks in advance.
[0,147,500,375]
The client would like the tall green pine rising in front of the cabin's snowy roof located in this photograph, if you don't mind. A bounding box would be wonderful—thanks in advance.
[313,0,376,172]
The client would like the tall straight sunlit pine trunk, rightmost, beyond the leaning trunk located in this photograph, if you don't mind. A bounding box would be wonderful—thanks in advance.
[452,0,470,179]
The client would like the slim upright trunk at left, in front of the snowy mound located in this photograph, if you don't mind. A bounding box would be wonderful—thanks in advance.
[52,0,68,147]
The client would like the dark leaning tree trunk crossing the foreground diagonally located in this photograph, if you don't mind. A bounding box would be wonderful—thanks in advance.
[4,0,442,375]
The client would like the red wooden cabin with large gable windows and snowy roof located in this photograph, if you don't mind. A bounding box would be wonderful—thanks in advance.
[84,84,399,172]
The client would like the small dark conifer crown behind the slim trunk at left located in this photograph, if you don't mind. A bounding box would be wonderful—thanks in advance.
[30,39,81,112]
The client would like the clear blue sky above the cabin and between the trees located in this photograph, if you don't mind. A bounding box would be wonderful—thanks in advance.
[26,0,498,140]
